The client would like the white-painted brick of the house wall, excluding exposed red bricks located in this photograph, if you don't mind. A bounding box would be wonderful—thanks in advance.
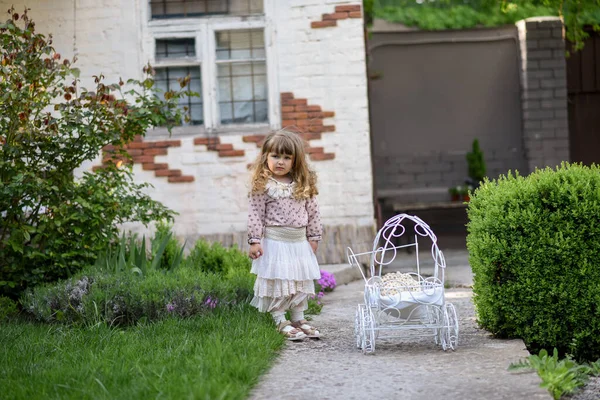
[0,0,374,244]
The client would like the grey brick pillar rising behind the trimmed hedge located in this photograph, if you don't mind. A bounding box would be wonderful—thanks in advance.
[517,17,569,172]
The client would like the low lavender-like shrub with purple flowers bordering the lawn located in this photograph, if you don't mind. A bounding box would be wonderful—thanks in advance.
[21,239,254,325]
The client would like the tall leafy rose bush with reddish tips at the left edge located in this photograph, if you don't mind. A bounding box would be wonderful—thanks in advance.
[0,9,187,297]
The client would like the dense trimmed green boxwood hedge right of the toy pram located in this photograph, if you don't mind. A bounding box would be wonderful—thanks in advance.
[467,163,600,361]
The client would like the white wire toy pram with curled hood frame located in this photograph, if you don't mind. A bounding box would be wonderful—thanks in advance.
[347,214,458,354]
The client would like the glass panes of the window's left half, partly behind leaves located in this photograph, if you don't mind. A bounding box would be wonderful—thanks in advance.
[154,39,204,125]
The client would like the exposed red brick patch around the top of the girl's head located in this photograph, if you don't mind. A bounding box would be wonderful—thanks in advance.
[243,92,335,161]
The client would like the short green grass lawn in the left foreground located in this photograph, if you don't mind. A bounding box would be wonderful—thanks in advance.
[0,305,284,400]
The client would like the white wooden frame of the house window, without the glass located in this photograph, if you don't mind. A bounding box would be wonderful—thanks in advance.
[140,0,281,136]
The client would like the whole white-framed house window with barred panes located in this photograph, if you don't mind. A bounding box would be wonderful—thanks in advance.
[144,0,280,134]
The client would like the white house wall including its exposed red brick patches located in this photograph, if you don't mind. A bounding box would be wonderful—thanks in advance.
[5,0,374,263]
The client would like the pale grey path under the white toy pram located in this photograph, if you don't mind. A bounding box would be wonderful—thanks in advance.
[250,280,552,400]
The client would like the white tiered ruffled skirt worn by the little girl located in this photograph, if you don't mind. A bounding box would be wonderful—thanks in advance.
[250,227,321,312]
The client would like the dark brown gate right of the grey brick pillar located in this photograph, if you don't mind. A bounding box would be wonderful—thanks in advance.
[567,29,600,165]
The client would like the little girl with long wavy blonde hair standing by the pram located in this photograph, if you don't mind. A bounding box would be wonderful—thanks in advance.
[248,130,322,340]
